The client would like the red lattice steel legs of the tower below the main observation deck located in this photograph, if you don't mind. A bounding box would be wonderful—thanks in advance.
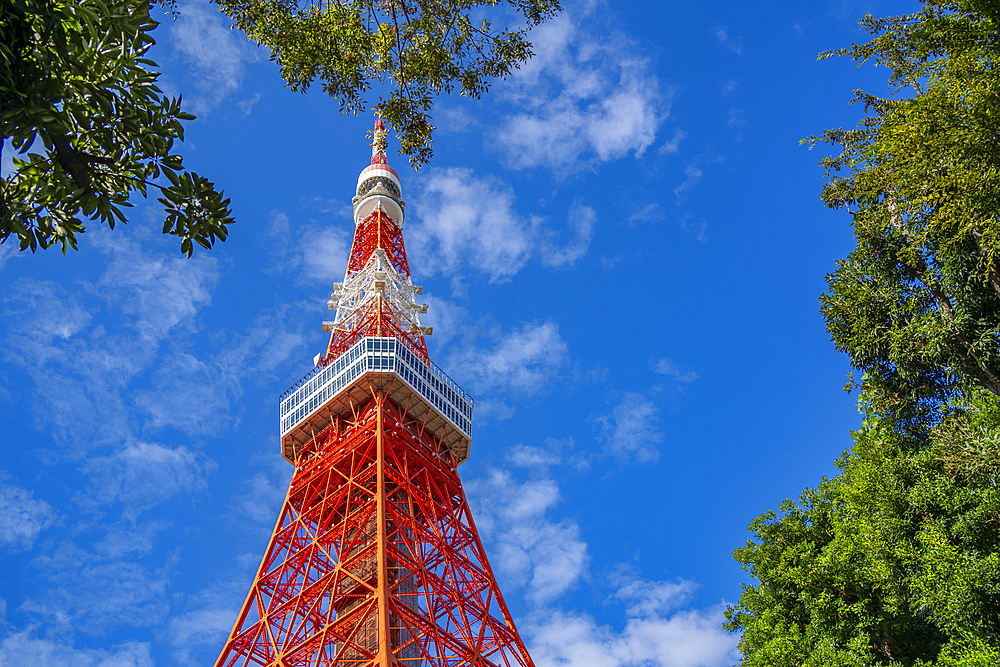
[216,392,533,667]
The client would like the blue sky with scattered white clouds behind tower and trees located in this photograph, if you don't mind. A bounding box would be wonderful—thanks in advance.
[0,0,917,667]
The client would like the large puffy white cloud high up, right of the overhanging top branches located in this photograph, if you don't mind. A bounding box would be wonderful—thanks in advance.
[494,10,668,174]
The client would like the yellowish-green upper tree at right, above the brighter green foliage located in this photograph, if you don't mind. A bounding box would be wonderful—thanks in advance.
[808,0,1000,412]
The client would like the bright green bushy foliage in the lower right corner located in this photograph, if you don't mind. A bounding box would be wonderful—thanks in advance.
[727,392,1000,667]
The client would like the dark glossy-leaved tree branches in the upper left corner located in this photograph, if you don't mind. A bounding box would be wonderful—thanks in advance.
[0,0,233,256]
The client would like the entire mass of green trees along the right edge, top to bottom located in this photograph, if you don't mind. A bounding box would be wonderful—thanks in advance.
[727,0,1000,667]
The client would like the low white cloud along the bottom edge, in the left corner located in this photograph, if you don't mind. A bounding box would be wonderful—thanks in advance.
[0,630,155,667]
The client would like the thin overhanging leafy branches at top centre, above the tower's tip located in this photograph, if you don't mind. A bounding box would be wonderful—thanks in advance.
[217,0,560,168]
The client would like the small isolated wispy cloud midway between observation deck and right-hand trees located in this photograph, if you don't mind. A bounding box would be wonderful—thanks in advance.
[594,392,663,463]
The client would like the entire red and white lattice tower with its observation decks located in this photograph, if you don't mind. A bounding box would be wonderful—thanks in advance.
[215,118,534,667]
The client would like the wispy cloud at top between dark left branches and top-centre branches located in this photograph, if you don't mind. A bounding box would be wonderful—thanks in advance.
[170,2,260,115]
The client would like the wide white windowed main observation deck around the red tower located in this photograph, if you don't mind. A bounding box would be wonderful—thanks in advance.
[279,336,474,464]
